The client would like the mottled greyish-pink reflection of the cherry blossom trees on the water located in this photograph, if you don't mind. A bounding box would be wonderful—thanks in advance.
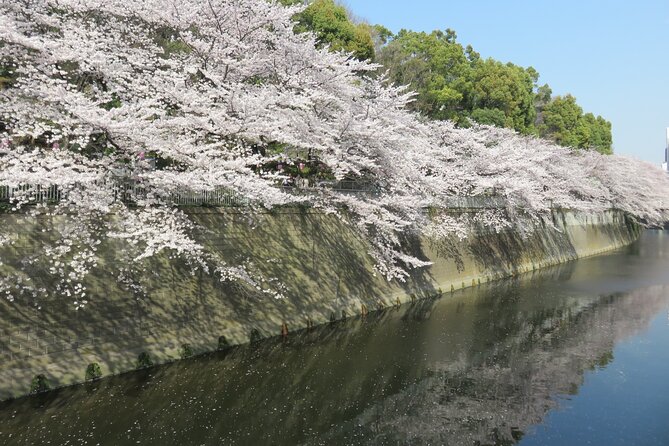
[329,286,669,445]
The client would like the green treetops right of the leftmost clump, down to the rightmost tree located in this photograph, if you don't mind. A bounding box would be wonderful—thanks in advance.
[377,30,612,153]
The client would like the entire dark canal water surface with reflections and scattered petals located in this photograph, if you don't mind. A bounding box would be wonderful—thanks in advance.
[0,231,669,445]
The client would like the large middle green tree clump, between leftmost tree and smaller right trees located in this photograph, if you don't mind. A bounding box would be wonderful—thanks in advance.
[377,29,539,133]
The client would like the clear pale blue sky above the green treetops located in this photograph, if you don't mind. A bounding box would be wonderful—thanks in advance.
[342,0,669,164]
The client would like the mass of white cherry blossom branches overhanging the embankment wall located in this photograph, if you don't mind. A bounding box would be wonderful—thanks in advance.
[0,0,669,305]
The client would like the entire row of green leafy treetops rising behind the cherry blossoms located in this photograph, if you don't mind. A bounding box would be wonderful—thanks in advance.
[283,0,612,154]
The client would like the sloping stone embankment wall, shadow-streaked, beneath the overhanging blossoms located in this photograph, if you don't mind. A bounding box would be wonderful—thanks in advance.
[0,208,638,400]
